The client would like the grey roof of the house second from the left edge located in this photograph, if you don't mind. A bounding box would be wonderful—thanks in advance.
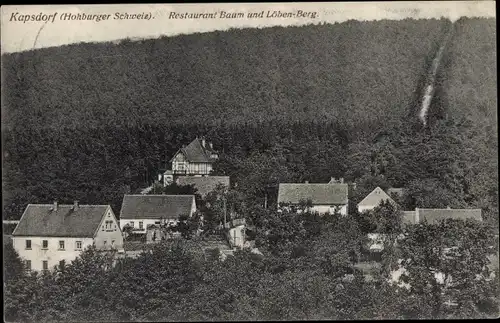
[120,195,195,219]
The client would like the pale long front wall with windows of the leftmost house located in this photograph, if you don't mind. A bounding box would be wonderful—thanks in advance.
[12,237,94,271]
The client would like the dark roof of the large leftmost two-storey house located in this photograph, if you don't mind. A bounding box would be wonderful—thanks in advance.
[12,204,110,238]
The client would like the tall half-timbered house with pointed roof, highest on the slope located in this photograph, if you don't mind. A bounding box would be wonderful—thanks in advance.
[170,137,219,176]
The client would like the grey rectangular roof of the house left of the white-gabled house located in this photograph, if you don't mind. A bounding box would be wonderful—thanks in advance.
[278,183,348,205]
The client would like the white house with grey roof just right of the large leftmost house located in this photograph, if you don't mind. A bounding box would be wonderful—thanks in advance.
[120,195,196,233]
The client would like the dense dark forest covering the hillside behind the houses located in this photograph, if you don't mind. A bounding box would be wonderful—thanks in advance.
[2,18,498,232]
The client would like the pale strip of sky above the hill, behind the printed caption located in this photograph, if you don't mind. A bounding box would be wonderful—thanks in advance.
[1,1,495,53]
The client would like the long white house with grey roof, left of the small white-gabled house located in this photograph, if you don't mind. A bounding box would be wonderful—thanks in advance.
[278,178,349,215]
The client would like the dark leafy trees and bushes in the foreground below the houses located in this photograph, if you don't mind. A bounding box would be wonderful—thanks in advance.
[5,214,498,322]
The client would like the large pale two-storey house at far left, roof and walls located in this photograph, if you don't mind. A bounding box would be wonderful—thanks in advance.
[12,201,123,271]
